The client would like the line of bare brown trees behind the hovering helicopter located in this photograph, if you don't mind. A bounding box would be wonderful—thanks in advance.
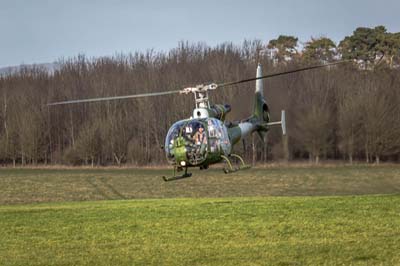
[0,26,400,165]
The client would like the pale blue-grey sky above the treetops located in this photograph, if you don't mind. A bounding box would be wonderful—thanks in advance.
[0,0,400,67]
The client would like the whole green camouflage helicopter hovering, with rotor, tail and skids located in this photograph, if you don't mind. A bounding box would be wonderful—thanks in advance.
[48,61,343,181]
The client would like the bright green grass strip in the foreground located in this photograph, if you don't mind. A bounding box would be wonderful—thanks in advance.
[0,195,400,265]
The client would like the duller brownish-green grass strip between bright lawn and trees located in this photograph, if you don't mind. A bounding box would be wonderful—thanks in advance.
[0,165,400,205]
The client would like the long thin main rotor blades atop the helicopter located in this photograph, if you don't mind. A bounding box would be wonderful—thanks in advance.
[47,61,349,106]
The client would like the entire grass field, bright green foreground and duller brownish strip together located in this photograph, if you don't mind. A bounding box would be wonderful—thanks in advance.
[0,165,400,265]
